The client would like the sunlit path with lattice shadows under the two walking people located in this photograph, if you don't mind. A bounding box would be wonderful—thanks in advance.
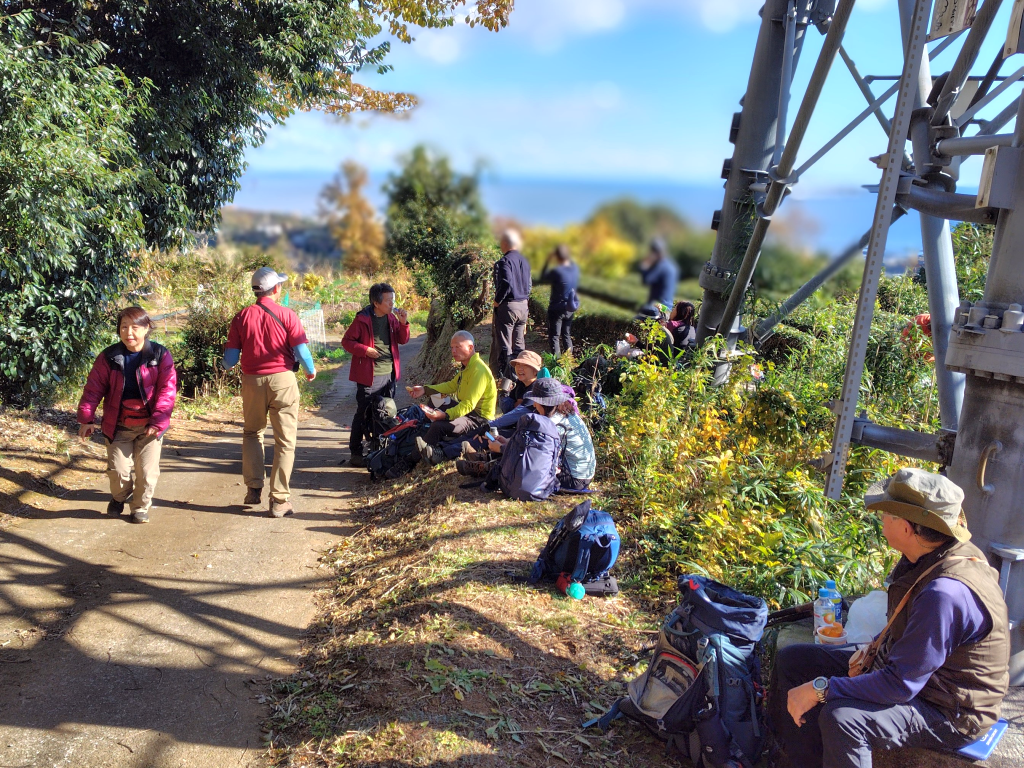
[0,341,417,768]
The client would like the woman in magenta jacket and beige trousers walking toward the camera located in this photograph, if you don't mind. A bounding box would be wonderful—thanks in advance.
[78,306,177,522]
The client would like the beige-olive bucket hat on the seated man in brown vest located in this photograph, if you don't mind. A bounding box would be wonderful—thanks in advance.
[864,467,971,542]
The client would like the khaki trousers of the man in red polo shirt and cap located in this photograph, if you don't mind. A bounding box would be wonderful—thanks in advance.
[242,371,299,503]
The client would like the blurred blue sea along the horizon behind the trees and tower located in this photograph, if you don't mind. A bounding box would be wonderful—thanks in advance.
[234,172,933,258]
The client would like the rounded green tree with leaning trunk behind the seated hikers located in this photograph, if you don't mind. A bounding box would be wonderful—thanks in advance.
[384,145,500,375]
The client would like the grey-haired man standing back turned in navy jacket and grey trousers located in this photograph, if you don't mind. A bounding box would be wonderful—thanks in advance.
[488,229,534,378]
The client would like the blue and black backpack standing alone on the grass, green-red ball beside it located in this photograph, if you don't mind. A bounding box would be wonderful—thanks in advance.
[528,499,620,595]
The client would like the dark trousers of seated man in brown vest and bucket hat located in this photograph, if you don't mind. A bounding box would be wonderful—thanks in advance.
[768,644,971,768]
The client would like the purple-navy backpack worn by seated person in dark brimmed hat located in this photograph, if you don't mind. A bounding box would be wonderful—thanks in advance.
[497,414,562,502]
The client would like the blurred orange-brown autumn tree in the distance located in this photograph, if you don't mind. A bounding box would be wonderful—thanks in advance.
[319,160,384,274]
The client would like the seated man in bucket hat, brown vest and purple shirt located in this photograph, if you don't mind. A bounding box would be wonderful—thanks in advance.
[768,469,1010,768]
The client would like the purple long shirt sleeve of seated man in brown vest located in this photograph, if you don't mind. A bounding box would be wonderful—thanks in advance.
[827,577,992,705]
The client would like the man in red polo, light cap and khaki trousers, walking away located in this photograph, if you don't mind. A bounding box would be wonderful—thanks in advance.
[224,266,316,517]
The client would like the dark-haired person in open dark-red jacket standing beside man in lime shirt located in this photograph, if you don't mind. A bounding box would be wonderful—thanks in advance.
[341,283,409,467]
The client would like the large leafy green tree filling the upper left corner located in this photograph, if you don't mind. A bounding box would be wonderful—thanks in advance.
[0,0,512,400]
